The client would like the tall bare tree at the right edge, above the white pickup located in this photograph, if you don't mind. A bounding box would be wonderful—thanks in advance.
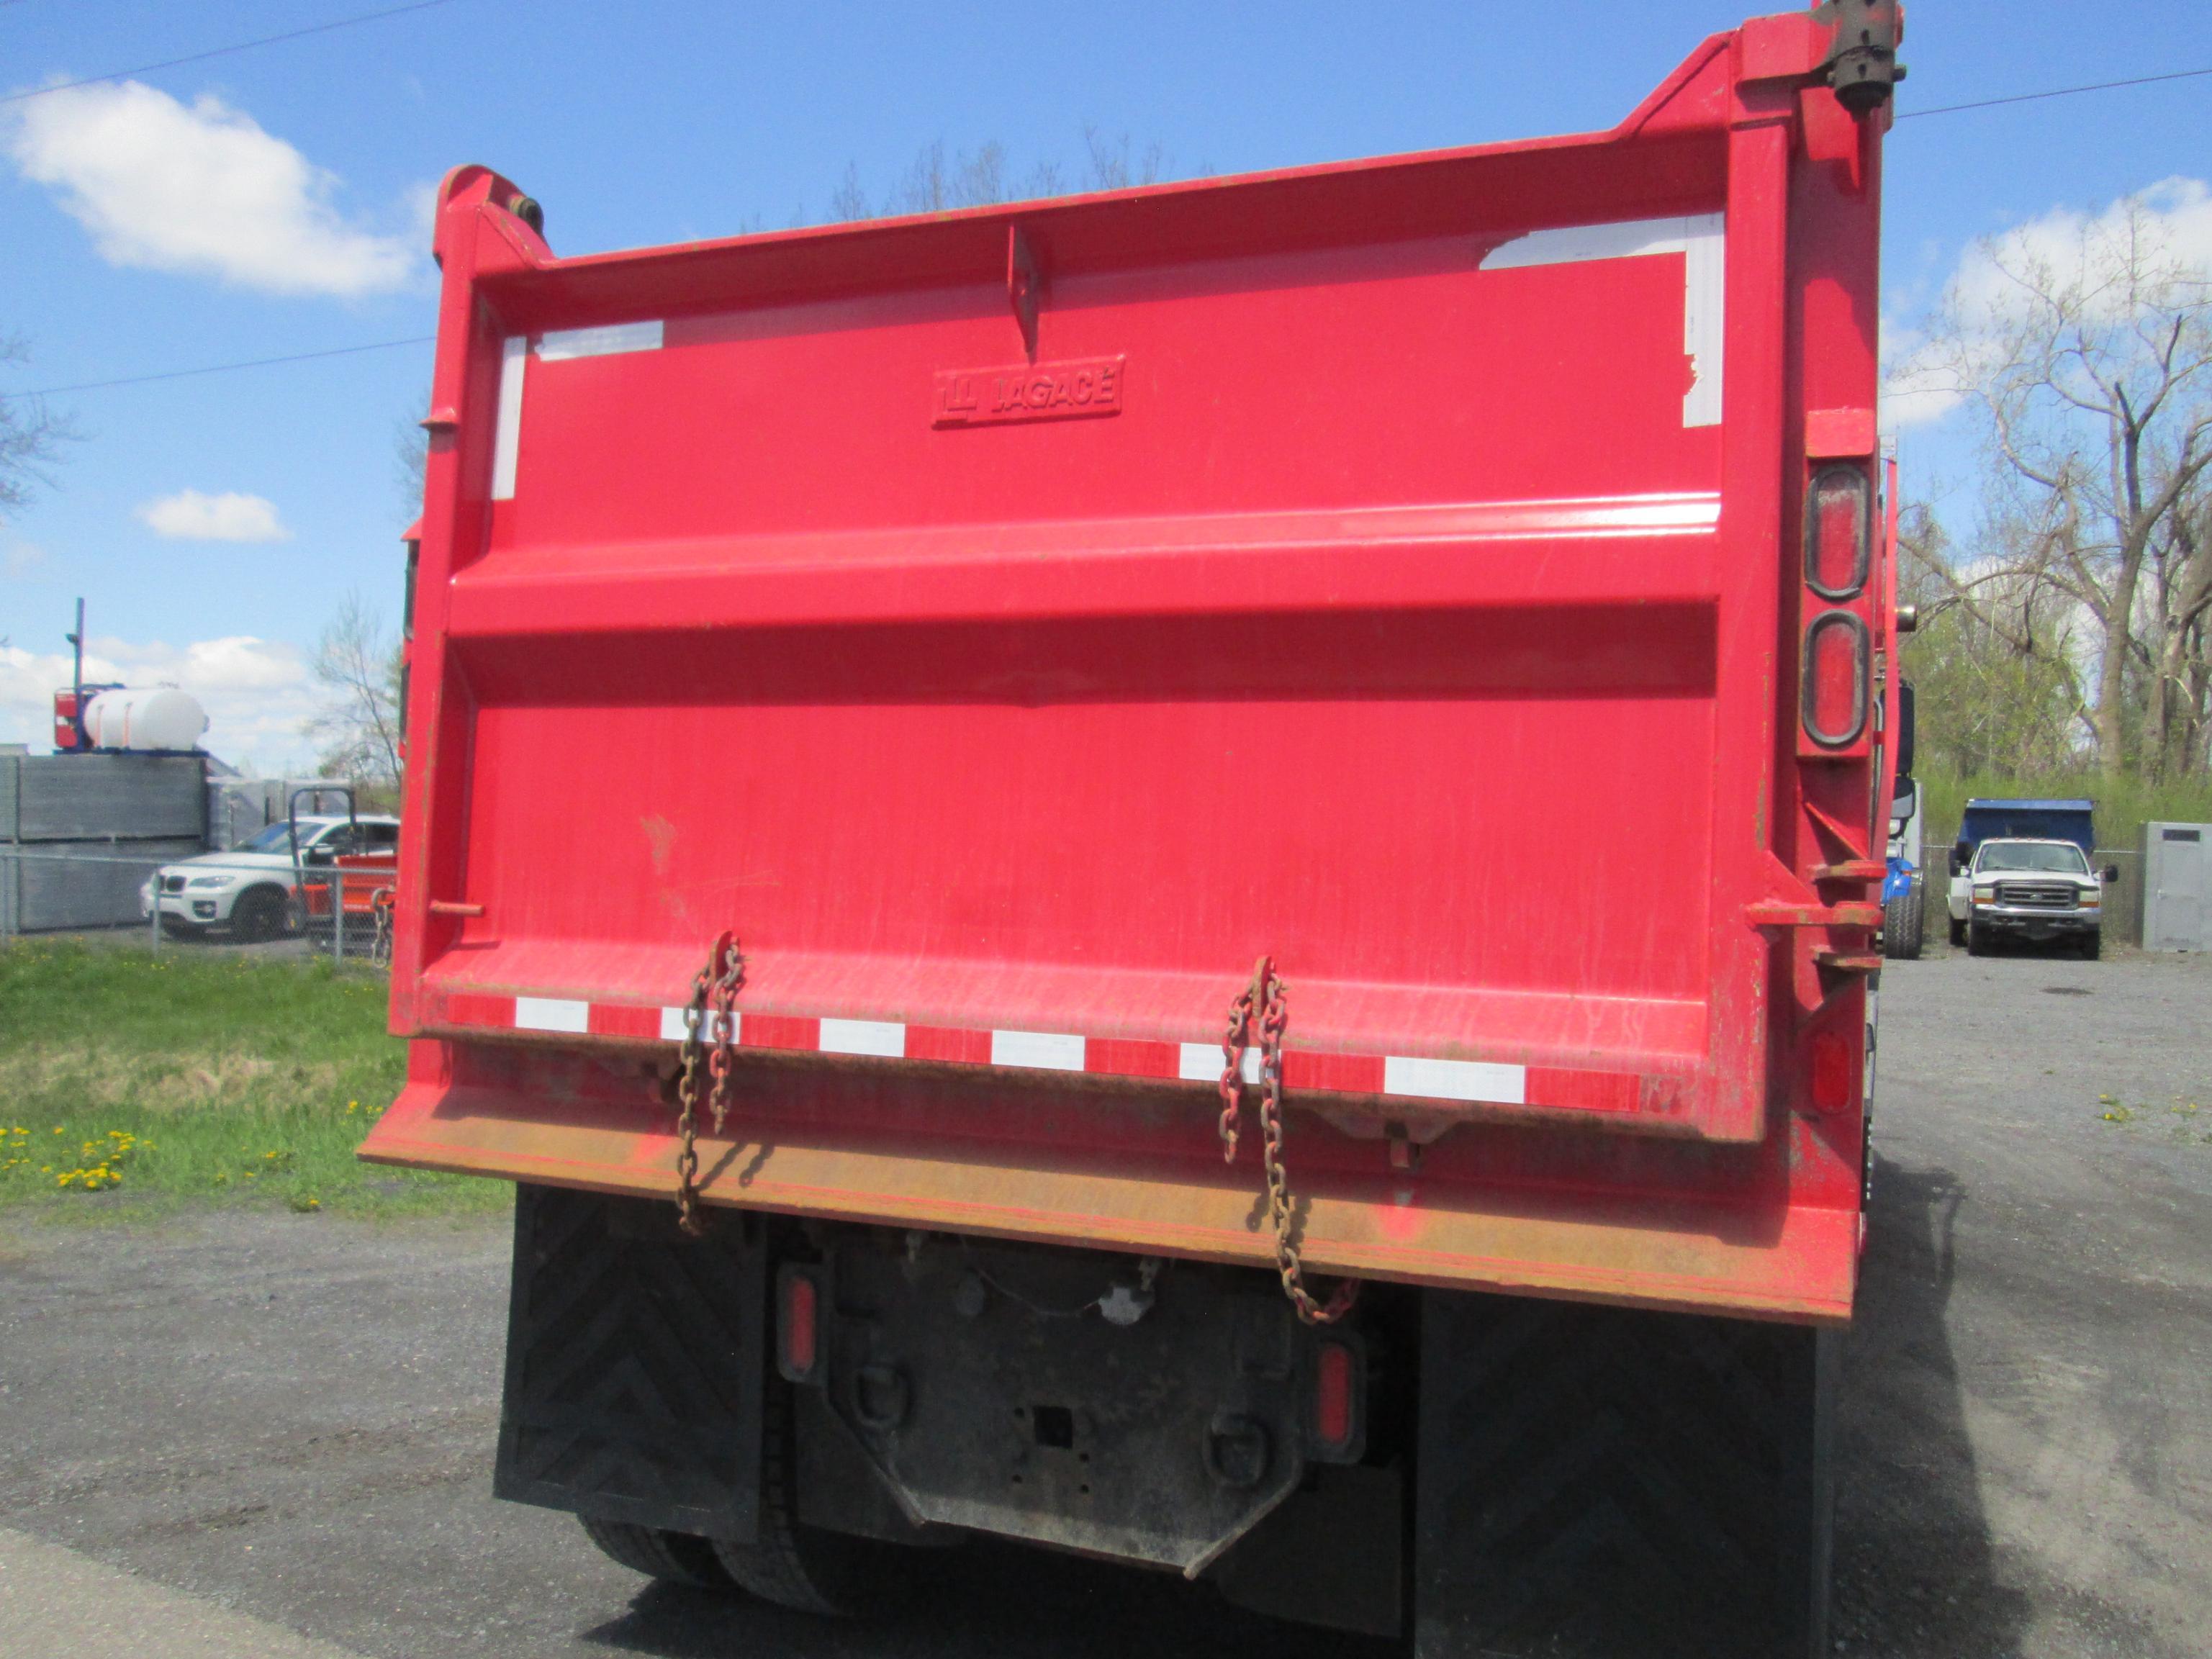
[1922,192,2212,777]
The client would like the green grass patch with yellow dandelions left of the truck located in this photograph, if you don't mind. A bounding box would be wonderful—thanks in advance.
[0,940,511,1214]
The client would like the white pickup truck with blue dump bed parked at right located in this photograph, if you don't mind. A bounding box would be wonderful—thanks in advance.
[1949,798,2119,956]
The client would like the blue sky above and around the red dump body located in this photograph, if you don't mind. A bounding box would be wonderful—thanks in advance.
[0,0,2212,770]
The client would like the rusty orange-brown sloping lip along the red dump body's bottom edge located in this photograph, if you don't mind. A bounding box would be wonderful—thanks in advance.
[361,1084,1858,1323]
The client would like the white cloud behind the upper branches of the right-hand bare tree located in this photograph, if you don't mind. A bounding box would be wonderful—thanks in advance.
[1882,177,2212,429]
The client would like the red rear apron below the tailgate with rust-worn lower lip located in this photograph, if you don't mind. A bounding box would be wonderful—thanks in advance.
[361,1042,1860,1321]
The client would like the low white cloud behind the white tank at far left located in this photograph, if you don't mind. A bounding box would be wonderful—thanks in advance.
[0,635,314,770]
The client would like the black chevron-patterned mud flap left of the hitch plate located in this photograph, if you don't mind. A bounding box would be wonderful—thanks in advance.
[493,1185,767,1542]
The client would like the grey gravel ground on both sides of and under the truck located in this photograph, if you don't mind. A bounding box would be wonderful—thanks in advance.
[0,954,2212,1659]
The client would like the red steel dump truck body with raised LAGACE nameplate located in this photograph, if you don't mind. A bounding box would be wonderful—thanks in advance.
[365,3,1896,1321]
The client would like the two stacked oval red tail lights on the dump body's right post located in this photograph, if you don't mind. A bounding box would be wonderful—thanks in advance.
[1798,462,1874,754]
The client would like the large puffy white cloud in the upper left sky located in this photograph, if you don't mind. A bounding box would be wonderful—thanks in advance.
[6,82,423,299]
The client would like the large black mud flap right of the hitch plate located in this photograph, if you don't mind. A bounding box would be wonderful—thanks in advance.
[1414,1292,1841,1659]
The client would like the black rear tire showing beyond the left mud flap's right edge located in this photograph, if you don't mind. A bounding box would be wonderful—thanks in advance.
[713,1378,929,1619]
